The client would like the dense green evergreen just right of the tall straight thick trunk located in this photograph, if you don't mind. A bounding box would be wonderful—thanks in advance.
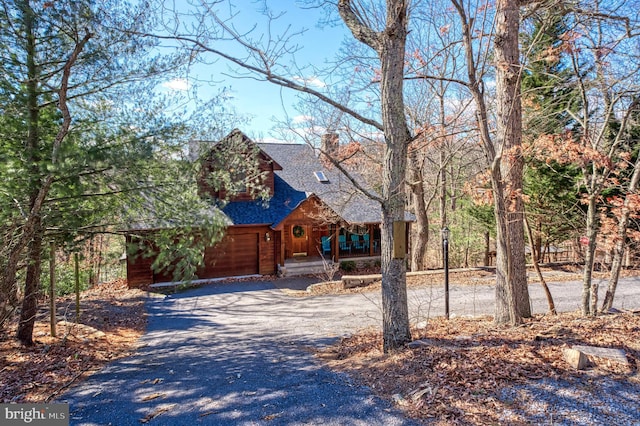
[522,9,581,257]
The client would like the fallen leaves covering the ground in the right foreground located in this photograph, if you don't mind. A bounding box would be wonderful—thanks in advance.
[318,313,640,424]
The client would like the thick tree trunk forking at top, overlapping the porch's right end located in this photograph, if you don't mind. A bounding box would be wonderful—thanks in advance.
[338,0,411,353]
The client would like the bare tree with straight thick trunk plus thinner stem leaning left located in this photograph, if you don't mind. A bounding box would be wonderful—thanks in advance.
[440,0,531,324]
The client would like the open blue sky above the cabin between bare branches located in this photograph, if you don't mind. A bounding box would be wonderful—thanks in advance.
[166,0,346,140]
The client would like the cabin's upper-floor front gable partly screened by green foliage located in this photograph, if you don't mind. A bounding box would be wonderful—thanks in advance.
[198,129,282,201]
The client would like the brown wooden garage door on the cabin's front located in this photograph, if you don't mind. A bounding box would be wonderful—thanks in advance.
[198,232,259,278]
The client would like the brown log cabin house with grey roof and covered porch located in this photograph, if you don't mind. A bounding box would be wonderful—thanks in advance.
[127,129,408,287]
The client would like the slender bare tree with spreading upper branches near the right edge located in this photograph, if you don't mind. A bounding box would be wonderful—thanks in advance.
[565,0,640,315]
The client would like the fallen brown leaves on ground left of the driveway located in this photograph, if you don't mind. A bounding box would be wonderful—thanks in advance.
[0,280,146,403]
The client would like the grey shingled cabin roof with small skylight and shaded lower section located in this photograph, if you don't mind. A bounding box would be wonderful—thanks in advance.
[223,138,381,226]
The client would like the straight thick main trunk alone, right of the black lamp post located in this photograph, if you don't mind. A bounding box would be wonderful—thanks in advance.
[494,0,531,323]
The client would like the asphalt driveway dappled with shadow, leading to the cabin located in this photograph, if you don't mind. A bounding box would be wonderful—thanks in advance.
[60,278,640,426]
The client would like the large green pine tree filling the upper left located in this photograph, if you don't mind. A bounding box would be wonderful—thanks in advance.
[0,0,238,345]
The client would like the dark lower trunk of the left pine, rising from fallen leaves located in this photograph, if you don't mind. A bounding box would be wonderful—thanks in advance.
[16,217,42,346]
